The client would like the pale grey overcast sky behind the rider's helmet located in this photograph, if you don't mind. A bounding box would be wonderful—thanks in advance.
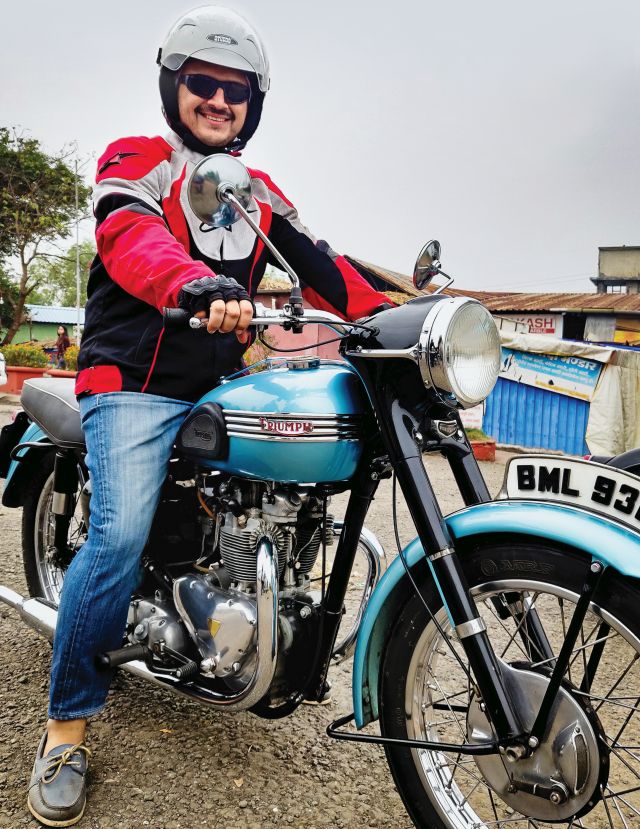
[0,0,640,291]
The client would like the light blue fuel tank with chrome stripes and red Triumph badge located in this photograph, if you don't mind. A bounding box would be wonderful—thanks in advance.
[192,358,369,483]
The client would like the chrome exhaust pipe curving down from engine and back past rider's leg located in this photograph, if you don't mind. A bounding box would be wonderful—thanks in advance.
[0,537,278,711]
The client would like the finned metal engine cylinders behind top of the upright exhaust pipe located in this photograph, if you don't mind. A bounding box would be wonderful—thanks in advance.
[220,519,292,582]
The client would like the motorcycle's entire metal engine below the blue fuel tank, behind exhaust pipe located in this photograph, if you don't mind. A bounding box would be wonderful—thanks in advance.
[128,473,334,689]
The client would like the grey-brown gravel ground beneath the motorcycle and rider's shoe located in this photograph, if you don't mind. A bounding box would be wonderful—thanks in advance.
[0,406,508,829]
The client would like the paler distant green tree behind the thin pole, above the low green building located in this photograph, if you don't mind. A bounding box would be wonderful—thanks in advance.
[29,241,96,308]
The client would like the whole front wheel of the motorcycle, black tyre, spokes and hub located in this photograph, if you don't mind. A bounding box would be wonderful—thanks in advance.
[379,538,640,829]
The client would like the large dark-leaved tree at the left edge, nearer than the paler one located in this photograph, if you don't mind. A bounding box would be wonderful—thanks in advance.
[0,127,90,344]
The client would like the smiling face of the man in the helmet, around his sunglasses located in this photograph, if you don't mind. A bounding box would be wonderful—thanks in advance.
[178,60,249,147]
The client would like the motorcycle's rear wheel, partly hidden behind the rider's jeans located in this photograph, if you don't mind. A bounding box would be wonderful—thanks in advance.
[22,452,86,606]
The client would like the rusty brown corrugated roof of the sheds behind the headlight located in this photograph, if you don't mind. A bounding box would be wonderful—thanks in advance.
[346,256,640,314]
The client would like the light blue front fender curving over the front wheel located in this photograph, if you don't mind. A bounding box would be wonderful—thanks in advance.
[353,501,640,728]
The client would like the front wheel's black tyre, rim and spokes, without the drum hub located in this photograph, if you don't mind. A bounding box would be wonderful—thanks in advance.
[379,538,640,829]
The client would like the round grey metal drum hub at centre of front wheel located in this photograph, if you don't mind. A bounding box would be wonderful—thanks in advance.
[467,662,608,821]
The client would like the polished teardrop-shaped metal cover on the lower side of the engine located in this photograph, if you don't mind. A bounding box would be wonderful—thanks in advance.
[173,574,257,679]
